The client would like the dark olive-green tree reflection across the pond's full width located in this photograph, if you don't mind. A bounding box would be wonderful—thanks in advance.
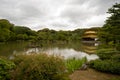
[0,41,95,56]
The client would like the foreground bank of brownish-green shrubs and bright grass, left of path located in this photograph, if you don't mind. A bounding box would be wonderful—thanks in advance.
[0,54,86,80]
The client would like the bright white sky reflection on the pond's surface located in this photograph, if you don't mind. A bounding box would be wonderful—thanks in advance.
[40,48,98,60]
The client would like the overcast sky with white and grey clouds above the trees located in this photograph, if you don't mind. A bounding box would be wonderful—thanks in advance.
[0,0,120,30]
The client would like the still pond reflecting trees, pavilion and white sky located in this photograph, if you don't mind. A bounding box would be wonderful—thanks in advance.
[0,41,98,60]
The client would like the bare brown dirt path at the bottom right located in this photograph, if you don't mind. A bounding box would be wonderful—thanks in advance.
[70,69,120,80]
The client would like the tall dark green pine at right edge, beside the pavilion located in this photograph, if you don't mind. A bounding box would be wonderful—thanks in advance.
[99,3,120,44]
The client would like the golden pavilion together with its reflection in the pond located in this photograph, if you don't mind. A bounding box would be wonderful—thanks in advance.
[82,29,98,54]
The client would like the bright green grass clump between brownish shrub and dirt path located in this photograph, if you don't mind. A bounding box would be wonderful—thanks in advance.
[65,58,86,72]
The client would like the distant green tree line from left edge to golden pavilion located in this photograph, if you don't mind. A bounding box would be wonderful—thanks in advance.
[0,19,85,42]
